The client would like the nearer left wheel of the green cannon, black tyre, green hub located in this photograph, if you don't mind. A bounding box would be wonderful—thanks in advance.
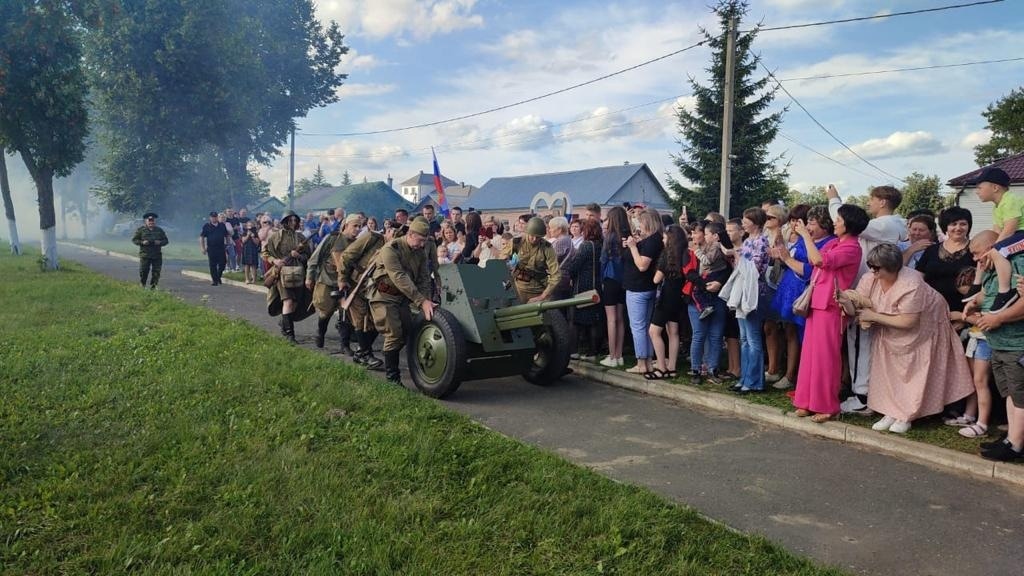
[406,307,468,398]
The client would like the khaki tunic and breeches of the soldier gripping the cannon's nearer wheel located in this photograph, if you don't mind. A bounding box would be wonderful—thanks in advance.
[368,238,430,352]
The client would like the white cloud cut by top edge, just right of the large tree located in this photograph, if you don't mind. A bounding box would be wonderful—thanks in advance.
[316,0,483,41]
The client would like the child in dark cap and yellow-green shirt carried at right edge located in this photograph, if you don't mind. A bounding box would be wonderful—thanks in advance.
[975,168,1024,314]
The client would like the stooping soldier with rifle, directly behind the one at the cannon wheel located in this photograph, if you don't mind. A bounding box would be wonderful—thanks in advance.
[334,215,385,370]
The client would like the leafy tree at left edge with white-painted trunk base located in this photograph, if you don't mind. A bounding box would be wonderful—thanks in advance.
[0,0,88,270]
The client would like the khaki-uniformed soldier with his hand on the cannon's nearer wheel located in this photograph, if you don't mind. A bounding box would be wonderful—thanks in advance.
[369,220,434,383]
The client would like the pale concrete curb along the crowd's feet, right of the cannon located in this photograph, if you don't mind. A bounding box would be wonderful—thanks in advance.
[571,361,1024,487]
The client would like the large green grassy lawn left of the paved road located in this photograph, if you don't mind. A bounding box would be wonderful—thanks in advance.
[0,246,839,575]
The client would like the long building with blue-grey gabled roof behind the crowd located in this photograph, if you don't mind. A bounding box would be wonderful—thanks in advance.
[470,163,672,222]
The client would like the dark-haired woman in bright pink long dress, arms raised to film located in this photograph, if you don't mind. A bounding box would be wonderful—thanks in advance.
[793,204,868,423]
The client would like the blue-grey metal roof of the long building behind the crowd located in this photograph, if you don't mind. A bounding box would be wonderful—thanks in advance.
[471,164,669,210]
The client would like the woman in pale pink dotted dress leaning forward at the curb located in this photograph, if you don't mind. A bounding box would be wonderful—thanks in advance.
[857,244,974,434]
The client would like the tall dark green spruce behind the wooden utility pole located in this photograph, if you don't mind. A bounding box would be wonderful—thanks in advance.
[669,0,788,215]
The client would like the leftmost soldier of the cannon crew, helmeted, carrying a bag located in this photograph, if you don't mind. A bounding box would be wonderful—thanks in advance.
[262,210,309,343]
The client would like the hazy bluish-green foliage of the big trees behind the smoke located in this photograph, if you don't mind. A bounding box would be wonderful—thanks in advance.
[82,0,347,212]
